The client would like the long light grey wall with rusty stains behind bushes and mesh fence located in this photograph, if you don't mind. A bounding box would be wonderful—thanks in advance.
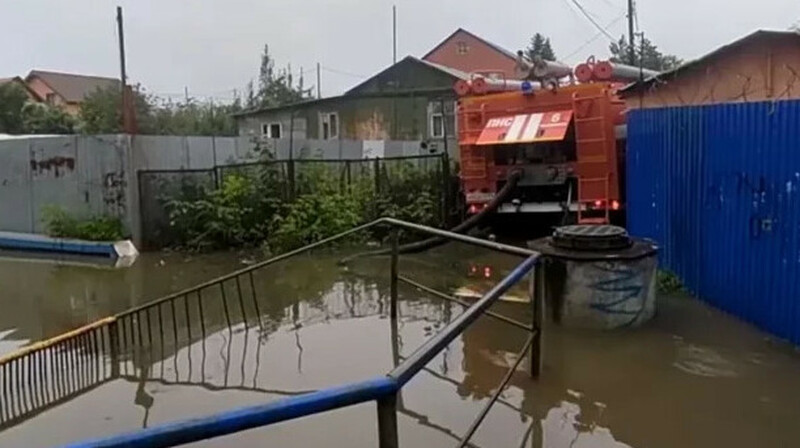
[0,135,456,250]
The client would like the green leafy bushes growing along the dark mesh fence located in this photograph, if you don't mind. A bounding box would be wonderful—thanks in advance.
[165,161,441,253]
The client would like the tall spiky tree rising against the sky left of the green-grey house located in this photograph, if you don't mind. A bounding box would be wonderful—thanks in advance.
[254,45,311,107]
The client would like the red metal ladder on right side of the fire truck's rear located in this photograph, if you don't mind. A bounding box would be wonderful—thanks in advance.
[572,91,616,224]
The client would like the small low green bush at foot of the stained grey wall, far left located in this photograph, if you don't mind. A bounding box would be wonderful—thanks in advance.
[42,205,124,241]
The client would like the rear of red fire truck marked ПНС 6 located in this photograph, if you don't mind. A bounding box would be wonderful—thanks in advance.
[457,83,625,223]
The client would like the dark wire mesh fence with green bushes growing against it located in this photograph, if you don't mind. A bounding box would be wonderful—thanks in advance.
[138,154,456,249]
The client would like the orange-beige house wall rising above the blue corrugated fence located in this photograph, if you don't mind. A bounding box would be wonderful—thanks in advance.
[625,36,800,109]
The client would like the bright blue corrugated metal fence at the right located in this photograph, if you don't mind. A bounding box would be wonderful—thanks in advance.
[627,101,800,344]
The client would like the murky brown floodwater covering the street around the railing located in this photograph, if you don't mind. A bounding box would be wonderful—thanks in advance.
[0,245,800,448]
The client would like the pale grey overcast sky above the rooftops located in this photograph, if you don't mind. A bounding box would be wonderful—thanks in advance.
[0,0,800,100]
